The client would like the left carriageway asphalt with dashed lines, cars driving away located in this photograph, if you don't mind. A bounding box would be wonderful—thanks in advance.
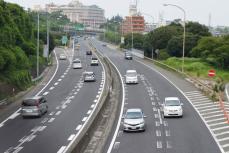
[0,40,104,153]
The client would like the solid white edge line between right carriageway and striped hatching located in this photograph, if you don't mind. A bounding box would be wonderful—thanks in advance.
[136,60,224,152]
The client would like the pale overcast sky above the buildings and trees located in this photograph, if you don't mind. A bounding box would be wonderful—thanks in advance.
[5,0,229,26]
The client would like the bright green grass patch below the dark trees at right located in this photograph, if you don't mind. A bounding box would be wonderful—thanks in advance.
[162,57,229,82]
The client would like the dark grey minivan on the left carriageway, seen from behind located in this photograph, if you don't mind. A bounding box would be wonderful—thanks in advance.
[21,96,48,117]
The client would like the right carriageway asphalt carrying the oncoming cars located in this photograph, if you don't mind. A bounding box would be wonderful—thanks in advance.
[90,40,220,153]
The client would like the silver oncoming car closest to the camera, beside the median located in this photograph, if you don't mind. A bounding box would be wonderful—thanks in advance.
[123,108,146,131]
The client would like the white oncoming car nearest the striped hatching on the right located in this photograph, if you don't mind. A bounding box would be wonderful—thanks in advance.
[162,97,183,117]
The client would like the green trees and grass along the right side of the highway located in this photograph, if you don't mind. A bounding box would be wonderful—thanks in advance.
[101,17,229,82]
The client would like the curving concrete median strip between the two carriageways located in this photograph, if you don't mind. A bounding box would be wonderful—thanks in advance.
[65,41,121,153]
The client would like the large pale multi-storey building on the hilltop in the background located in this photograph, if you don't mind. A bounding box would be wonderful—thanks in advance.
[46,0,105,29]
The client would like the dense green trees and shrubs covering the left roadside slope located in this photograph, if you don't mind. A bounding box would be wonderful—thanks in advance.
[0,1,69,100]
